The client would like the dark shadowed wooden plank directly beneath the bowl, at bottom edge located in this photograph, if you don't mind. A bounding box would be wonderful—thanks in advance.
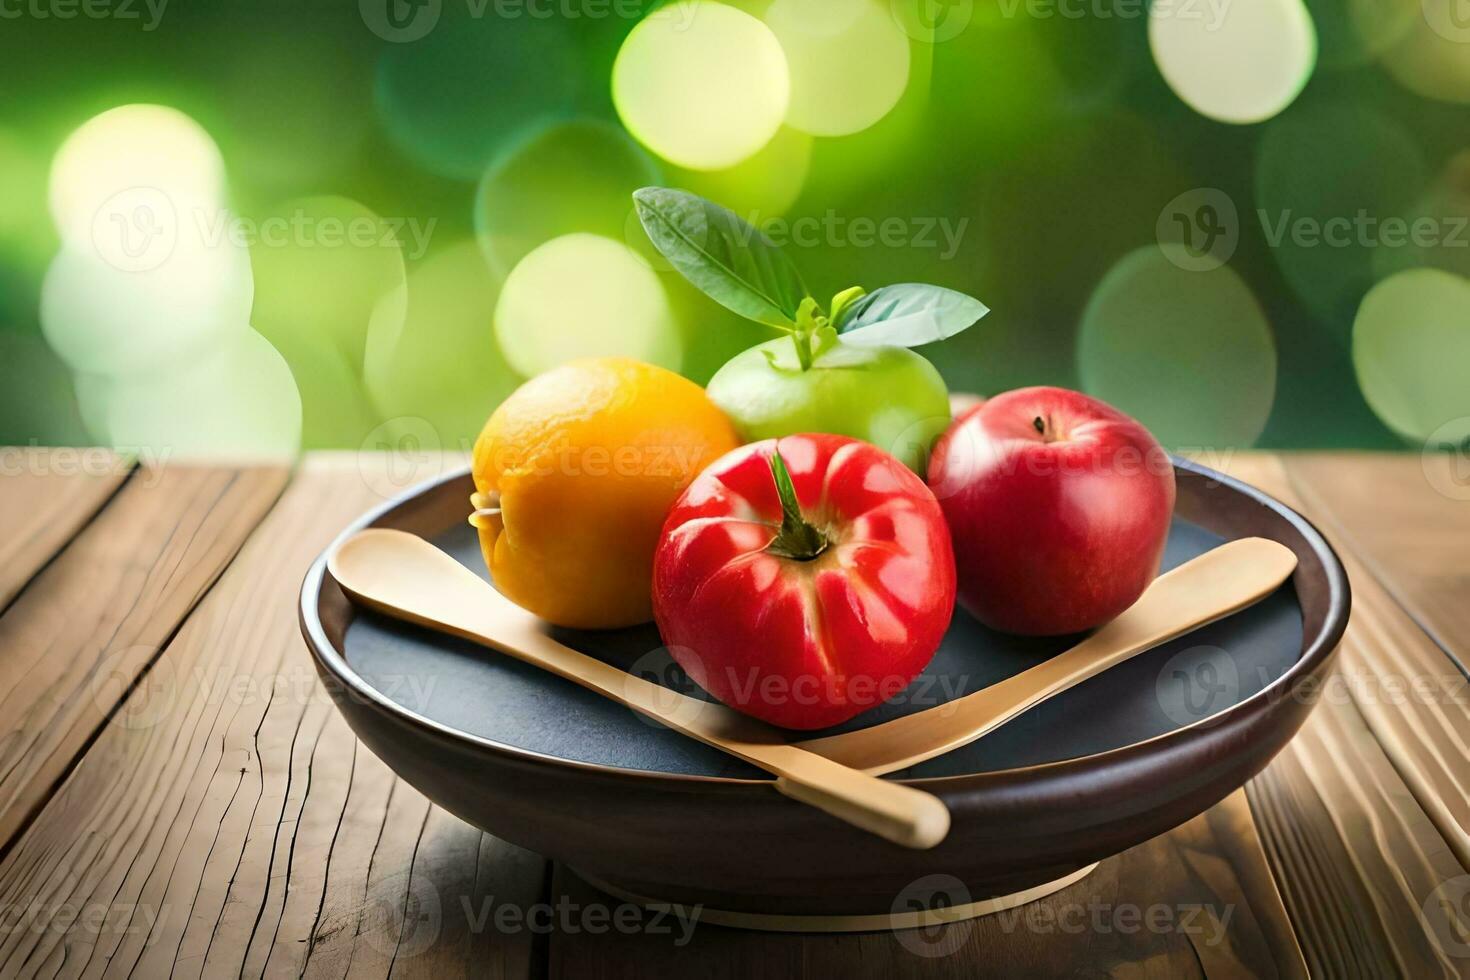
[550,792,1307,979]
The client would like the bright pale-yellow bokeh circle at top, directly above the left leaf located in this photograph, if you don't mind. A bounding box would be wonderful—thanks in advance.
[613,0,791,170]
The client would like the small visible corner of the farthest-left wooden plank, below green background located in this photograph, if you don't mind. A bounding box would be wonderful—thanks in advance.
[0,447,132,610]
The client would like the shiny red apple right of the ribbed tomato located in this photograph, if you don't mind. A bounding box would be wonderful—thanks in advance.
[929,388,1175,636]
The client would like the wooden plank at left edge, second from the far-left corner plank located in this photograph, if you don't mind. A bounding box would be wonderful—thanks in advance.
[0,466,287,854]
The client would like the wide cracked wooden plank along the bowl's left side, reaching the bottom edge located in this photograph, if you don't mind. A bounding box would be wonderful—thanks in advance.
[0,457,545,977]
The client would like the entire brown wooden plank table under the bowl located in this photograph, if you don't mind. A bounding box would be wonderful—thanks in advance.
[0,450,1470,980]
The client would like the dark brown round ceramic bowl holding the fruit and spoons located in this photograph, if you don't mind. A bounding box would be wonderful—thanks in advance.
[301,460,1348,915]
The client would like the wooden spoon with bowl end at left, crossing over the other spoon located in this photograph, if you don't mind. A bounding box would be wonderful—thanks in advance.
[326,527,950,849]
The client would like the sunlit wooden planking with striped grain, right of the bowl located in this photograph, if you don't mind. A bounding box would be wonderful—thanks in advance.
[1229,455,1470,977]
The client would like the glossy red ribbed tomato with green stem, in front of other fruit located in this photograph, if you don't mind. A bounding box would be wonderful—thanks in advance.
[653,433,954,729]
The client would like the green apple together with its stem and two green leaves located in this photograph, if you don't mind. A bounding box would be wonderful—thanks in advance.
[634,187,989,476]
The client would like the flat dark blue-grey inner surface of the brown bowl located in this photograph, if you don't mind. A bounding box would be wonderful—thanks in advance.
[344,520,1301,779]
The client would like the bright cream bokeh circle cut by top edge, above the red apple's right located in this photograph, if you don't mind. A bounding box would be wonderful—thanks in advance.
[1148,0,1317,123]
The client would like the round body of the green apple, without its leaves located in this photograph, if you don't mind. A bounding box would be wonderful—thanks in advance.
[707,329,950,476]
